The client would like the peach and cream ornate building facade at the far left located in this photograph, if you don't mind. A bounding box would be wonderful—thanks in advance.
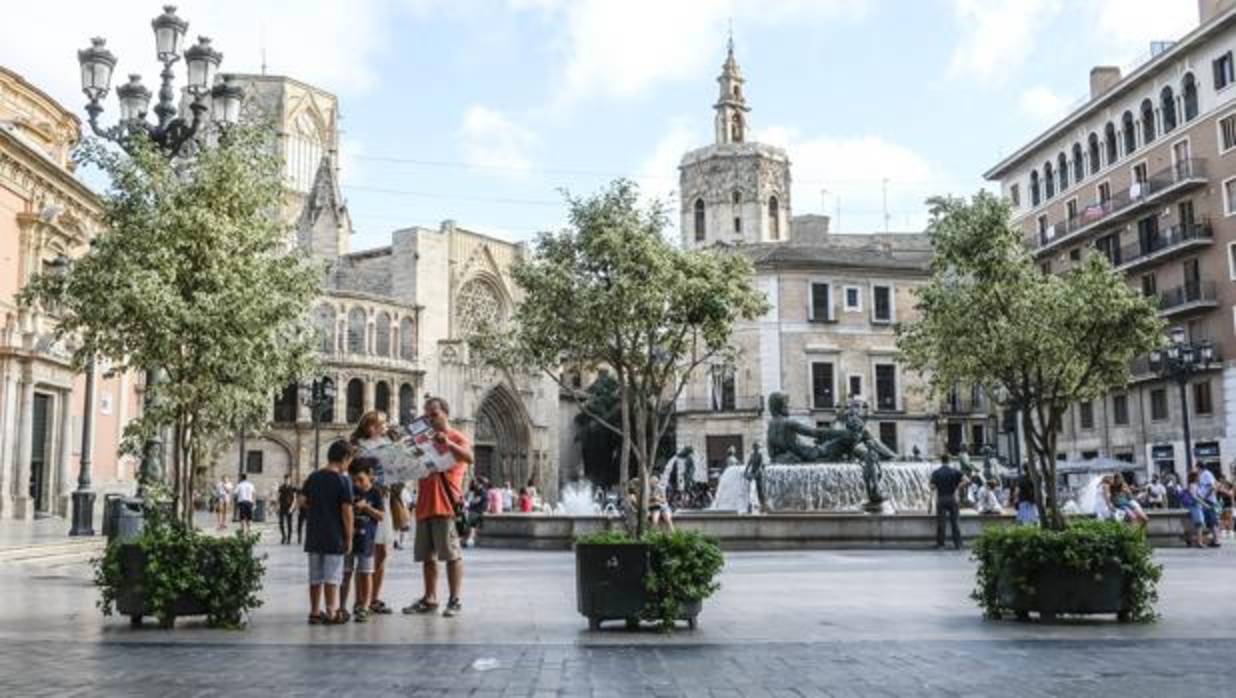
[0,67,141,519]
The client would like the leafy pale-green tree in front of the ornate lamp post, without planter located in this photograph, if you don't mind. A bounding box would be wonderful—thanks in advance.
[22,127,320,518]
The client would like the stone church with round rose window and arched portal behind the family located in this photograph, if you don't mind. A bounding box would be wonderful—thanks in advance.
[210,75,559,499]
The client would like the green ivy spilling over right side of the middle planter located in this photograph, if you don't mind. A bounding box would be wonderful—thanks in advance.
[577,531,726,633]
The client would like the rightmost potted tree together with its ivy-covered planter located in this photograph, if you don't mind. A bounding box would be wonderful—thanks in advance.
[897,191,1164,620]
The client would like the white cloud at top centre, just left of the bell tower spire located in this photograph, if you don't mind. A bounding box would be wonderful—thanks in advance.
[531,0,869,104]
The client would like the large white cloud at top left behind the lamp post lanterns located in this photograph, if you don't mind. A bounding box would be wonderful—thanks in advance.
[0,0,396,119]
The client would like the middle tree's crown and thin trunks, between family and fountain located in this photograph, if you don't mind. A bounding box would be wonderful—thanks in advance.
[471,180,768,534]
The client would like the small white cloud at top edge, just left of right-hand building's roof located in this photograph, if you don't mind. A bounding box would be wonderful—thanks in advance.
[949,0,1062,83]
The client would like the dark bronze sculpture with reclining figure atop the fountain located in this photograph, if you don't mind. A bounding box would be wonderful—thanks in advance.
[768,393,896,511]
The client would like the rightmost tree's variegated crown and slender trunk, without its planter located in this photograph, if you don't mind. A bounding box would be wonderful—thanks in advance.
[897,191,1163,529]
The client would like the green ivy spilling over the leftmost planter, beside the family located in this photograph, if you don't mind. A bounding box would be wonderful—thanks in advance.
[94,507,266,628]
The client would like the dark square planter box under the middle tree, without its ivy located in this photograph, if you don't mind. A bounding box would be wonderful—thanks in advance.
[575,542,703,630]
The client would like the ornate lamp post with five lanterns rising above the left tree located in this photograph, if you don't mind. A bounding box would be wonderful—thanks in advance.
[78,5,243,495]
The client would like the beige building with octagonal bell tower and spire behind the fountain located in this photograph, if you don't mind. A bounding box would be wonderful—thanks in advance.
[677,44,949,471]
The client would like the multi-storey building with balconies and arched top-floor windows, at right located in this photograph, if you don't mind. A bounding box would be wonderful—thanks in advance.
[985,0,1236,476]
